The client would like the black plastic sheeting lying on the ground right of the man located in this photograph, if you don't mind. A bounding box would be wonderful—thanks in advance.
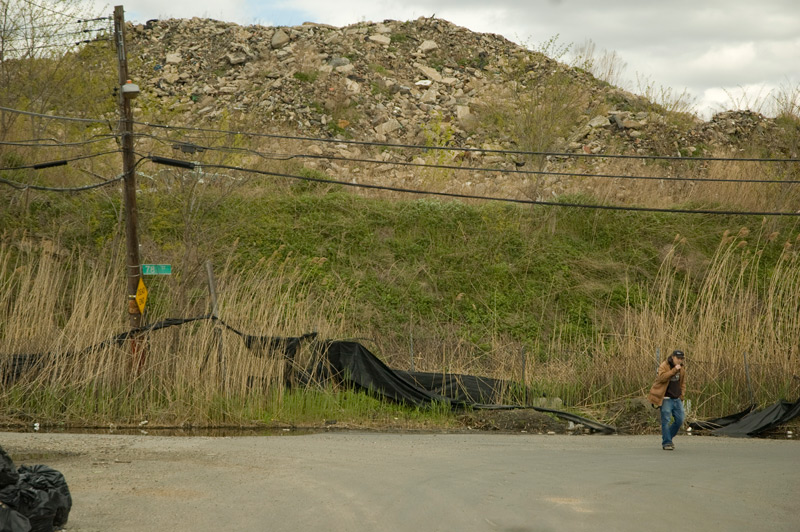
[691,399,800,438]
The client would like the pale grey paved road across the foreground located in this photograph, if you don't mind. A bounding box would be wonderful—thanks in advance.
[0,432,800,532]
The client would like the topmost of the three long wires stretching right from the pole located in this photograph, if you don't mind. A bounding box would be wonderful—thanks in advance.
[133,121,800,163]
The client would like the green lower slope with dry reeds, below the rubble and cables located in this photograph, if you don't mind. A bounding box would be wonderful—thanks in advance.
[0,175,800,426]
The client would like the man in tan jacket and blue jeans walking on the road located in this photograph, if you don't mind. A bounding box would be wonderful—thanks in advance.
[647,349,686,451]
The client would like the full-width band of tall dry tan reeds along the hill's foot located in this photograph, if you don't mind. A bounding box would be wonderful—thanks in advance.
[0,224,800,425]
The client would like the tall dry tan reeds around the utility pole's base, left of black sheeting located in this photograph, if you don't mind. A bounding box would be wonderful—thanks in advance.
[0,239,348,425]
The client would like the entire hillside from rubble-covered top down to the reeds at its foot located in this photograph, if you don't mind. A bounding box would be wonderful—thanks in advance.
[0,15,800,424]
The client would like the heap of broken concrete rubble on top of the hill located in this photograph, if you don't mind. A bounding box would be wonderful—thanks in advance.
[128,18,797,200]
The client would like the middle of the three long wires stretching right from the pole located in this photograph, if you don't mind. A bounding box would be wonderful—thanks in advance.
[134,134,800,185]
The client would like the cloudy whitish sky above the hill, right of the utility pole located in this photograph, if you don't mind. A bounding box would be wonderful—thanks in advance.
[109,0,800,118]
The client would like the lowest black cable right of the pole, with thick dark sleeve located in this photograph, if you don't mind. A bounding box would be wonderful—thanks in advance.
[147,155,800,216]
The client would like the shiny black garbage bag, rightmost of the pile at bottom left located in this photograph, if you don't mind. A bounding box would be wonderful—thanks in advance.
[17,465,72,532]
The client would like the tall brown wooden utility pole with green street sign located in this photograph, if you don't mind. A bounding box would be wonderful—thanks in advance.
[114,6,142,329]
